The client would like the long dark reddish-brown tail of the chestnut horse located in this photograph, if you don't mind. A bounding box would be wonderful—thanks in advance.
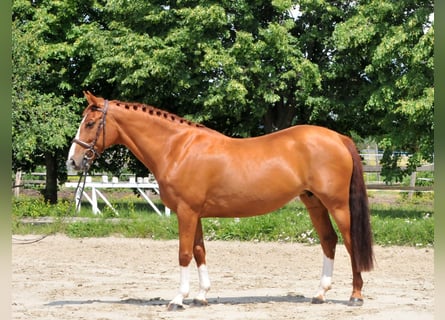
[343,137,374,271]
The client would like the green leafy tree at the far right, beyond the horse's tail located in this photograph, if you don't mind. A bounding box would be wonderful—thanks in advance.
[329,0,434,181]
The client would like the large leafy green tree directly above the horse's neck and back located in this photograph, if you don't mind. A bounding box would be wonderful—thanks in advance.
[78,1,320,136]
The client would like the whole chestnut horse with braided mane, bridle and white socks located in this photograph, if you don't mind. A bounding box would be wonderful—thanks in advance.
[67,92,374,310]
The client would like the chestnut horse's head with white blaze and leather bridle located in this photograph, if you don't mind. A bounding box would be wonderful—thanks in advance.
[67,91,109,170]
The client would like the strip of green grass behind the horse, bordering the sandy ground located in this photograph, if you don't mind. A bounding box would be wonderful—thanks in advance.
[12,191,434,247]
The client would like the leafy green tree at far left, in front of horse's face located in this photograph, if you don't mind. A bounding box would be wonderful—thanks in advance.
[12,0,92,203]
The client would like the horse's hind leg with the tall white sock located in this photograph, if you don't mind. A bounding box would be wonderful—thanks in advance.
[300,192,338,303]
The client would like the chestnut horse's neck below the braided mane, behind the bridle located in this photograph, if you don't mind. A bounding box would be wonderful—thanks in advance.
[113,107,187,176]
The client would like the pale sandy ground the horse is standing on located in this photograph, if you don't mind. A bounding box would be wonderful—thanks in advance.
[12,235,434,320]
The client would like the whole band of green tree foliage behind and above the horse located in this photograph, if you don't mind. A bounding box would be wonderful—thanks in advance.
[12,0,434,202]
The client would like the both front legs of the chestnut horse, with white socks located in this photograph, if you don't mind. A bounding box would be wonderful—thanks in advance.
[168,210,210,310]
